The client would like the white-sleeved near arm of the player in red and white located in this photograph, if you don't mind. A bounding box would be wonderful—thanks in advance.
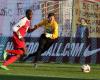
[13,18,26,39]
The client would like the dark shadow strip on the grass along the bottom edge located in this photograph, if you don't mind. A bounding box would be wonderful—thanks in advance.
[0,75,94,80]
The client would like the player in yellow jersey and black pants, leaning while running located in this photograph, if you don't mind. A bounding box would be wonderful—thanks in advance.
[23,13,58,63]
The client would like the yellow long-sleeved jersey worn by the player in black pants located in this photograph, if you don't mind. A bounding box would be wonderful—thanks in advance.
[37,19,58,39]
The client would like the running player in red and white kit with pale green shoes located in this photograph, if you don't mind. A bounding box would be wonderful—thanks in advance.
[0,9,32,70]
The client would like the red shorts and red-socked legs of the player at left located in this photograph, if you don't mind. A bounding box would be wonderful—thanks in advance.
[0,37,25,70]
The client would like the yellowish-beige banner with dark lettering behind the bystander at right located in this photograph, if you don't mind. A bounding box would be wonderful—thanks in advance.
[72,0,100,38]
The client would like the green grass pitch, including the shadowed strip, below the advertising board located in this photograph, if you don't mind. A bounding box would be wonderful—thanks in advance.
[0,63,100,80]
